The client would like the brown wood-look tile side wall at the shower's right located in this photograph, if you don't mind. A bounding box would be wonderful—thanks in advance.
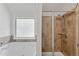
[62,12,76,56]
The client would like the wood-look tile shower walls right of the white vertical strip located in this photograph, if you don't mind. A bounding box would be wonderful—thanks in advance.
[54,12,76,56]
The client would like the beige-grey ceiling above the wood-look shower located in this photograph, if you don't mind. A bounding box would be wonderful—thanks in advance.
[42,3,77,11]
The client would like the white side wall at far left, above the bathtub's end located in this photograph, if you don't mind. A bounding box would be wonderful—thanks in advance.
[0,3,10,42]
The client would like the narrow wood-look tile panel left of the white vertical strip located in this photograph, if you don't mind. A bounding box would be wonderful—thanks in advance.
[42,16,52,52]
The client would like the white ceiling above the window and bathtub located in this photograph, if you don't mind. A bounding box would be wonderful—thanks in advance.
[5,3,38,15]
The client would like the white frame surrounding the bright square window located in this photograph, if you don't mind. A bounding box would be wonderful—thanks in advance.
[14,18,37,41]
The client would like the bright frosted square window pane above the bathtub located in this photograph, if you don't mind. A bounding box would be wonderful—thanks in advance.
[16,19,35,37]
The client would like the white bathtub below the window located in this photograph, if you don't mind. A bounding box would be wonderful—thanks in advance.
[0,42,36,56]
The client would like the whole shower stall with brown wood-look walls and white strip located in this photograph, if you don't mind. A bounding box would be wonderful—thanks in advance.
[42,11,76,56]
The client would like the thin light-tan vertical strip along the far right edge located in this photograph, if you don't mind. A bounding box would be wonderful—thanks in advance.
[76,3,79,56]
